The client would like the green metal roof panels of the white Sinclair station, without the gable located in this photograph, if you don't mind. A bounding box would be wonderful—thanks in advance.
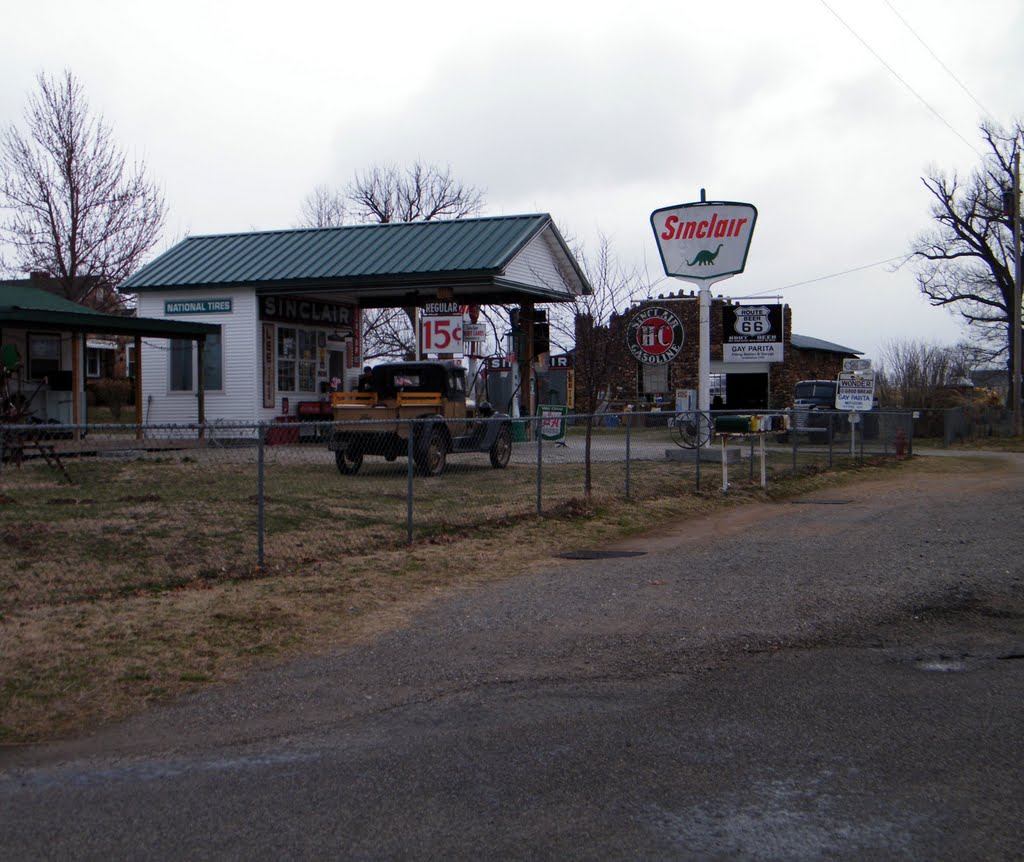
[119,213,589,303]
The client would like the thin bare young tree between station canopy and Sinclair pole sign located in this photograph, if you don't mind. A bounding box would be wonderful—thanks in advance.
[549,234,649,498]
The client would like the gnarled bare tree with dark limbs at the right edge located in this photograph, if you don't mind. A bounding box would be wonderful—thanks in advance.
[909,121,1024,384]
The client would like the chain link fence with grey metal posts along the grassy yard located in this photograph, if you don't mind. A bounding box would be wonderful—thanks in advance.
[0,412,913,581]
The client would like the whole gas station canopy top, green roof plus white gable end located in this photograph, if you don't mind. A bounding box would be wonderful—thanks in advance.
[119,213,591,308]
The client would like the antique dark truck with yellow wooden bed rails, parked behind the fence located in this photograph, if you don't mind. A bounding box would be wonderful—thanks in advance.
[328,361,512,476]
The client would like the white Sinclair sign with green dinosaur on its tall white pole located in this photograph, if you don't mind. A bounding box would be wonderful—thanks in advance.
[650,188,758,411]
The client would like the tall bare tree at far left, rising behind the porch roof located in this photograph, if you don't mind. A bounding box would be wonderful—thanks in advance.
[0,71,166,306]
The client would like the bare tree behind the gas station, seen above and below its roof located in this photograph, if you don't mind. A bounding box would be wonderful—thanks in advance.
[299,161,483,360]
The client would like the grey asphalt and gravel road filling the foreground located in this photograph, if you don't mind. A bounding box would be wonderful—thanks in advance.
[0,457,1024,860]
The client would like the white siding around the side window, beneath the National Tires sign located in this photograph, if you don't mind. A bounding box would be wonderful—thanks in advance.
[138,289,260,424]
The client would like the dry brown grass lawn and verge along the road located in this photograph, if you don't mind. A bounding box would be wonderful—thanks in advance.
[0,450,975,744]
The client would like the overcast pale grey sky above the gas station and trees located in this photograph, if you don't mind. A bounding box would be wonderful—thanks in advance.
[0,0,1024,358]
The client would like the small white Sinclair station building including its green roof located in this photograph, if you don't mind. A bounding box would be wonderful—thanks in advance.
[119,214,590,424]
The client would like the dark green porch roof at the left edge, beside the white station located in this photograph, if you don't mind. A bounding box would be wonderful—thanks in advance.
[0,282,220,338]
